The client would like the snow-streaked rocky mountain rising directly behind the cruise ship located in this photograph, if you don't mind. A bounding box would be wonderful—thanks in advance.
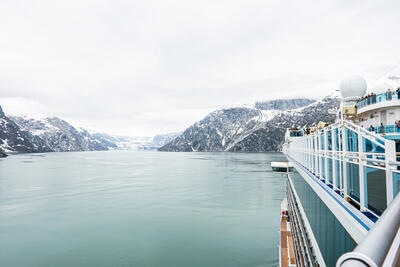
[160,95,340,152]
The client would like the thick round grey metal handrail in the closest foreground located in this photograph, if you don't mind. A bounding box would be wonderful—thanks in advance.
[336,194,400,267]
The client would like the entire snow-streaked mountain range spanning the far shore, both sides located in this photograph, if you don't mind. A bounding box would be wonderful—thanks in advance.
[0,94,339,156]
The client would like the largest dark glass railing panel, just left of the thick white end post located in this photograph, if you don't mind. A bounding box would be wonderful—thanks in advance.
[364,167,387,215]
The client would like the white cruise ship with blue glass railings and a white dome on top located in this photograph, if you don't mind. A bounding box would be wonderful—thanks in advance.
[279,76,400,267]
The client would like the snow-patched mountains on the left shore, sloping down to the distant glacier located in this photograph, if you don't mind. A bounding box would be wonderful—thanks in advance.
[0,107,178,157]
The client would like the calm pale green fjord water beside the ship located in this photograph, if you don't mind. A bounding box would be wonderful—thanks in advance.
[0,151,285,267]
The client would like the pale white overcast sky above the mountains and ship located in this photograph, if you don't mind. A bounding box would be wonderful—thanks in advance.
[0,0,400,135]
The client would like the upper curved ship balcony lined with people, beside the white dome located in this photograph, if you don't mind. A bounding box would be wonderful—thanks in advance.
[357,92,400,114]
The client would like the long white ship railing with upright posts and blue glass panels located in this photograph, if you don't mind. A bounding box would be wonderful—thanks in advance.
[284,121,400,220]
